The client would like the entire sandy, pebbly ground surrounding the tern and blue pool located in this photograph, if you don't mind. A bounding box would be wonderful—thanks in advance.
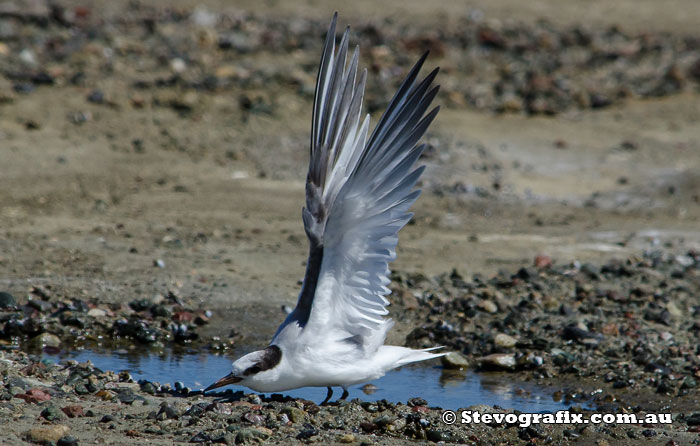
[0,0,700,445]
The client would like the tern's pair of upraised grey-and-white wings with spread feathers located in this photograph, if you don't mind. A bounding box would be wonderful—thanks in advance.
[289,15,438,344]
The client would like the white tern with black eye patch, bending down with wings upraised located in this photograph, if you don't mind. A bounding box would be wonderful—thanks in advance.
[205,13,444,404]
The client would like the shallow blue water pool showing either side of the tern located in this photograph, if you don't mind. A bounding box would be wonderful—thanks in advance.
[43,350,570,413]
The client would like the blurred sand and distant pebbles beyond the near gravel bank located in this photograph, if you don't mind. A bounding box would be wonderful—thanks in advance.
[0,0,700,318]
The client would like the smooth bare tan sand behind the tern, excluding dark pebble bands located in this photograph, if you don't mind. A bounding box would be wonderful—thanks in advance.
[0,0,700,444]
